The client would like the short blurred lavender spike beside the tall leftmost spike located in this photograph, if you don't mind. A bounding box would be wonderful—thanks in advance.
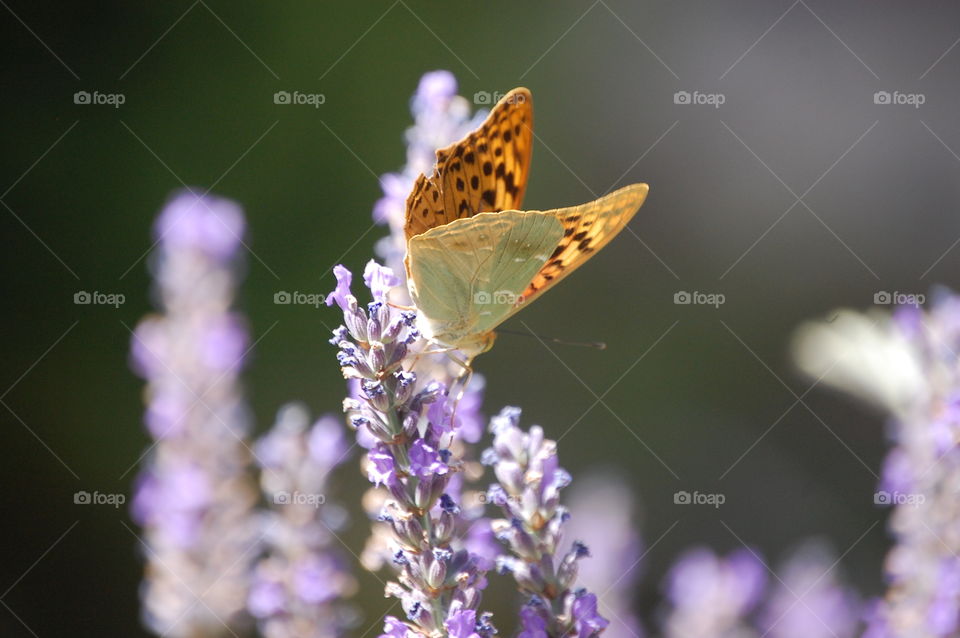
[247,404,356,638]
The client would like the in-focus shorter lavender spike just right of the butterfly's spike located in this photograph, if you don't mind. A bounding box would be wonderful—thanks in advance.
[484,408,609,638]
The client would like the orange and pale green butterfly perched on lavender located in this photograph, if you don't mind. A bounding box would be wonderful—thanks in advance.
[404,88,648,366]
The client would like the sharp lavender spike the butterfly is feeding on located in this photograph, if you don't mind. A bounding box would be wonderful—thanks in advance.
[328,264,496,638]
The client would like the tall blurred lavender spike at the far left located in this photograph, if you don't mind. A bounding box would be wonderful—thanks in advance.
[131,192,257,638]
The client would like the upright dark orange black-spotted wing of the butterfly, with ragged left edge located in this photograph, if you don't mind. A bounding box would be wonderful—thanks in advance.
[404,88,533,241]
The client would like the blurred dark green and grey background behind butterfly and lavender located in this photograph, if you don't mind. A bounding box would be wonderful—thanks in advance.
[0,0,960,638]
